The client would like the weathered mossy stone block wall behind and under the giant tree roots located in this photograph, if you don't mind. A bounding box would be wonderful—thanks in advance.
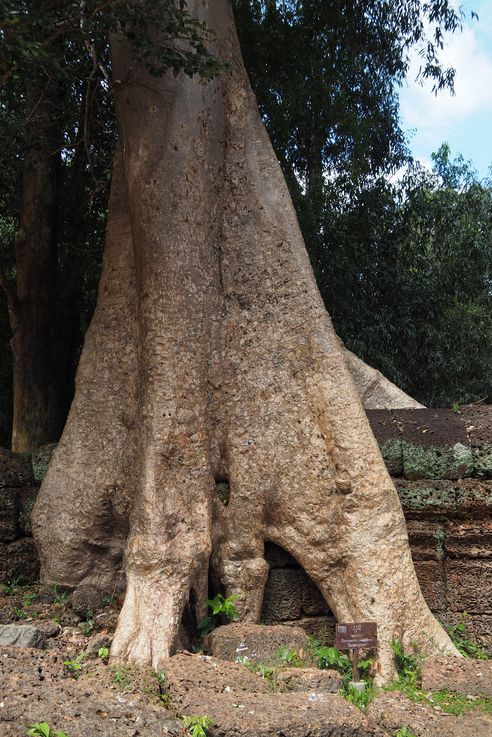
[0,406,492,654]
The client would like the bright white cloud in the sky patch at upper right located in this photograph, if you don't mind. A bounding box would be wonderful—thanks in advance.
[401,12,492,142]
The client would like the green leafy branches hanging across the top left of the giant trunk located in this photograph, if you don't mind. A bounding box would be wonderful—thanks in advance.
[0,0,222,84]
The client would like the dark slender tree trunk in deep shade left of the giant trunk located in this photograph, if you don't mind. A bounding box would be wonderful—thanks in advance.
[9,79,70,452]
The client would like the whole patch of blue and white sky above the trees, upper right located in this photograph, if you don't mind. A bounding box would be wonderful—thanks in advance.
[400,0,492,178]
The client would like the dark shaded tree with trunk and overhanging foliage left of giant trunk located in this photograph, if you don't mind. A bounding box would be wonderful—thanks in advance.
[0,0,221,451]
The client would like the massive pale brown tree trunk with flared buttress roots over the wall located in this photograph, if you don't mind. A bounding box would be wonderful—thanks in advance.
[34,0,456,678]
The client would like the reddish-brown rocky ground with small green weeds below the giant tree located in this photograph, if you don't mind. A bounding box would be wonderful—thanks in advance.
[0,585,492,737]
